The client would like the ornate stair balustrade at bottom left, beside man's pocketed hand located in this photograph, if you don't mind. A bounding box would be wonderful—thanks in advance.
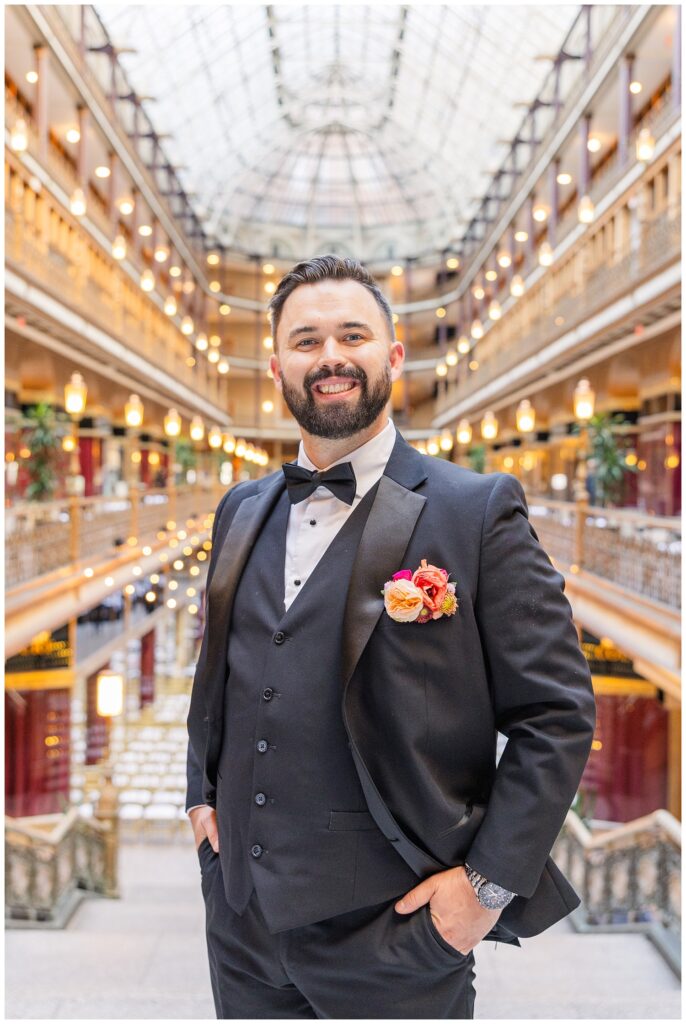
[5,784,118,928]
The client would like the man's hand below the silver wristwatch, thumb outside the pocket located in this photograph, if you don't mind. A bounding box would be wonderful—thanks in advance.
[395,866,502,955]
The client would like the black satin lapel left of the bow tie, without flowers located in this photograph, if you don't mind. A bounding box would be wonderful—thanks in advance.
[206,475,286,715]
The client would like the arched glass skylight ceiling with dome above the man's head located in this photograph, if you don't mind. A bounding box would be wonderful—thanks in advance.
[96,4,578,259]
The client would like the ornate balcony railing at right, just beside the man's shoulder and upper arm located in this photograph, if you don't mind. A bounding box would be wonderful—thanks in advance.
[527,496,681,608]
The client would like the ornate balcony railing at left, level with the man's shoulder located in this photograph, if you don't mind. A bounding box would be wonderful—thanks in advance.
[5,486,221,591]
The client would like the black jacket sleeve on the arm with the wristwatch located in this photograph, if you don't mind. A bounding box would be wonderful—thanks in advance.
[465,473,595,897]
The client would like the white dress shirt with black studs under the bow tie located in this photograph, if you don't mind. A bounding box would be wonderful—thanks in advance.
[284,420,395,610]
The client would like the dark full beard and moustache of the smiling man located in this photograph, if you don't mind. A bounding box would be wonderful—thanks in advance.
[282,362,391,439]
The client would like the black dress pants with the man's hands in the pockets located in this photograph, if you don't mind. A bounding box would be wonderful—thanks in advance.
[198,840,475,1020]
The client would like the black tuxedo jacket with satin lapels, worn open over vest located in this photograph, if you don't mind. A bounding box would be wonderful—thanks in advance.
[186,433,595,936]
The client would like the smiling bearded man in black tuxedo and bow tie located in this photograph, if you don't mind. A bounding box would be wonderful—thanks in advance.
[186,256,595,1019]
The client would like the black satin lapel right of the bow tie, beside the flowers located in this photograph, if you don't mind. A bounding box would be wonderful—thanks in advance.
[343,475,426,690]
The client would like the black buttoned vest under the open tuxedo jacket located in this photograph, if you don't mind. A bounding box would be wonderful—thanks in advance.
[217,485,418,932]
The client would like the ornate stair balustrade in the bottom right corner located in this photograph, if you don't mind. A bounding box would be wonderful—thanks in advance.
[553,810,681,973]
